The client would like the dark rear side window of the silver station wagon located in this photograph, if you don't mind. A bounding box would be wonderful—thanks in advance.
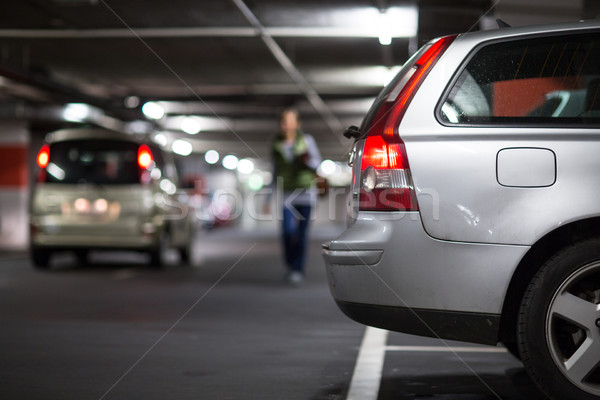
[439,33,600,125]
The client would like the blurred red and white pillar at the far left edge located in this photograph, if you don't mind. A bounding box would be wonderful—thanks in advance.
[0,121,30,250]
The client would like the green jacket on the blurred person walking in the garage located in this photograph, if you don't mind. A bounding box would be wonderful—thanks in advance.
[272,131,315,192]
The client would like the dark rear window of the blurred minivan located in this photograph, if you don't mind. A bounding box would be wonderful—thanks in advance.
[45,140,140,185]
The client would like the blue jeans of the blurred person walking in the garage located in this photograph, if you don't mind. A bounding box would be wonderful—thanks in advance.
[282,205,310,272]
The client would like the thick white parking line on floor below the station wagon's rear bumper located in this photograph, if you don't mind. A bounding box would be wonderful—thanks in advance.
[346,326,388,400]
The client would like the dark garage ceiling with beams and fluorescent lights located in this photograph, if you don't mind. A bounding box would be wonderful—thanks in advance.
[0,0,600,159]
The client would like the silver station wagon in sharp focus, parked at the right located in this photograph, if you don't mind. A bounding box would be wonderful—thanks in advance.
[323,21,600,400]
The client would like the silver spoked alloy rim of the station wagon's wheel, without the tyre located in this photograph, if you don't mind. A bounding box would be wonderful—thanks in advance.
[545,262,600,396]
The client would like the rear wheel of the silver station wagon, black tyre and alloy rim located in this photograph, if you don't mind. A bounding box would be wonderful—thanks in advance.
[517,239,600,400]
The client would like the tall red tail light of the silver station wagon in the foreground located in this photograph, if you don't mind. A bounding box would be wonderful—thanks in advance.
[359,36,456,211]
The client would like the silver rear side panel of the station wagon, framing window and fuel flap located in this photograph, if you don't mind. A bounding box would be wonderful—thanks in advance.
[399,22,600,245]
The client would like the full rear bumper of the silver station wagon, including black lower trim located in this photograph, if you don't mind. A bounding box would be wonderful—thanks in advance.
[323,212,529,343]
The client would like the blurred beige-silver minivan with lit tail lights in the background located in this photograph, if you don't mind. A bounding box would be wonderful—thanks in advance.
[30,128,193,268]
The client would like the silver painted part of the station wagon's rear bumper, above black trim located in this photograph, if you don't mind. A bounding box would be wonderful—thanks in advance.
[324,212,529,314]
